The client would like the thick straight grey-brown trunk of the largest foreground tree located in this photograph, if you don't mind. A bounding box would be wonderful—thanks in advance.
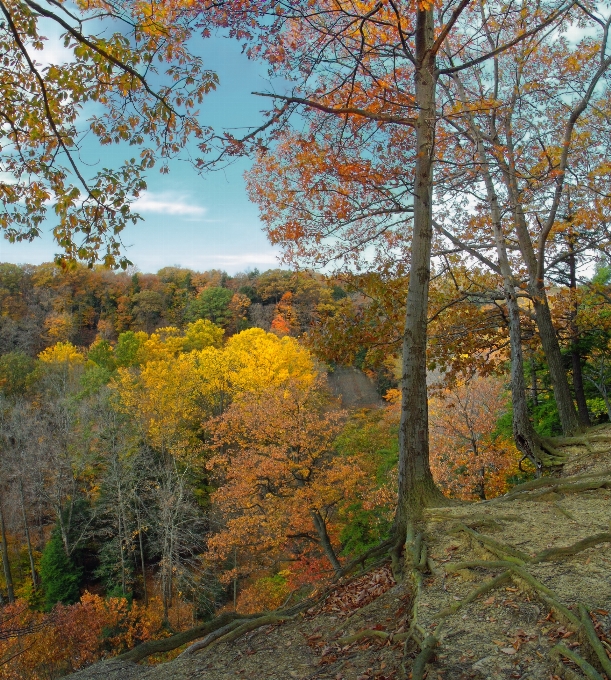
[395,9,443,537]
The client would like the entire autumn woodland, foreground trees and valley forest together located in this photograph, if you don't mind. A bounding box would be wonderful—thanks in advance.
[0,0,611,680]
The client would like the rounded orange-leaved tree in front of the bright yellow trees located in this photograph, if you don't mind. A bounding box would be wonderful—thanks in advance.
[209,378,362,577]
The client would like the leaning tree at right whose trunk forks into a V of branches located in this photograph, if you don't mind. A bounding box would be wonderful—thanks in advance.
[447,7,611,434]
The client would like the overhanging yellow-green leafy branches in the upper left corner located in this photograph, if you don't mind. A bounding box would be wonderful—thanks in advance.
[0,0,218,268]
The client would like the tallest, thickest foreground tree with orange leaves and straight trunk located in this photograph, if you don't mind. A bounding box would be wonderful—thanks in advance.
[222,0,572,536]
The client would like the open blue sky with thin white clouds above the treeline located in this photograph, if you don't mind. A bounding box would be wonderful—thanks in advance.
[0,29,286,274]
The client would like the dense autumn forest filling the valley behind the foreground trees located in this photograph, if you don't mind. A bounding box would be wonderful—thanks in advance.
[0,264,611,678]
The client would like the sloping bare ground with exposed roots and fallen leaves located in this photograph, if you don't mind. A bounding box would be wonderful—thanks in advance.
[70,426,611,680]
